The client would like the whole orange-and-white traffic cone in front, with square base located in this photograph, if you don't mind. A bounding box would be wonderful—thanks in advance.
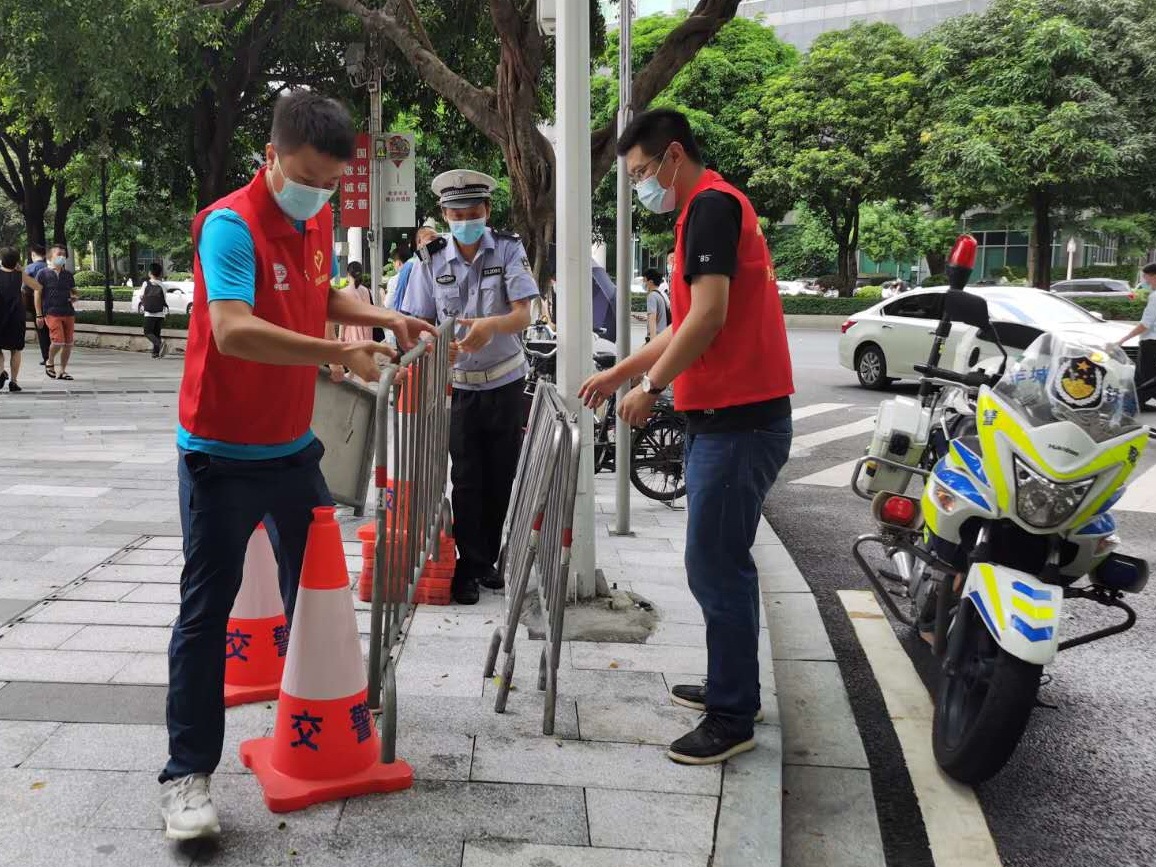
[240,506,414,813]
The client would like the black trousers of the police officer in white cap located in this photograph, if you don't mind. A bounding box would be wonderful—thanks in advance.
[450,379,525,578]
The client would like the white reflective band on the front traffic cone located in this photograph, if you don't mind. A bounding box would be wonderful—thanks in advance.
[281,587,365,701]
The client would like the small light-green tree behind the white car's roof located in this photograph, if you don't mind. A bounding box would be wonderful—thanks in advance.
[859,201,958,274]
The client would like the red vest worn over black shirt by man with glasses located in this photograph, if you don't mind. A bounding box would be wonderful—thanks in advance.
[670,169,794,412]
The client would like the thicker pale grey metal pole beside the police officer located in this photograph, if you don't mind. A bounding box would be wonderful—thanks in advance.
[555,0,596,599]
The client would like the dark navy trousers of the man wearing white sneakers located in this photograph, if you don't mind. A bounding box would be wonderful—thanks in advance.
[161,440,333,783]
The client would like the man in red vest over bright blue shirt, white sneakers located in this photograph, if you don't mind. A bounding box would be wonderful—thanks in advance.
[160,90,425,840]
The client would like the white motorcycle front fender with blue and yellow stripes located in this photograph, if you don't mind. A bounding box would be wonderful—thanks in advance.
[963,563,1064,666]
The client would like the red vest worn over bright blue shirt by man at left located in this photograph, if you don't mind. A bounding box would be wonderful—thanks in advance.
[180,168,333,445]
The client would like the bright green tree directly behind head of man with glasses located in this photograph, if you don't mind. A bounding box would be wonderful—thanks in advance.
[591,15,798,256]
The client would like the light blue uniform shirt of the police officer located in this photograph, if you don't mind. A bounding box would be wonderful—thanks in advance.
[401,227,538,391]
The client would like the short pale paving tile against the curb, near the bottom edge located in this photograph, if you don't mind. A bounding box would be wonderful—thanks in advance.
[586,788,719,855]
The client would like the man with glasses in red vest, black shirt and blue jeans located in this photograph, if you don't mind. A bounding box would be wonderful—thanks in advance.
[580,109,794,764]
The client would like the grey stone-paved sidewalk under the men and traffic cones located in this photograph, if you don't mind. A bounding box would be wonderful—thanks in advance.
[0,350,788,867]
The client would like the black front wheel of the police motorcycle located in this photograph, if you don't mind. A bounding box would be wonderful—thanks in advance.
[932,602,1043,785]
